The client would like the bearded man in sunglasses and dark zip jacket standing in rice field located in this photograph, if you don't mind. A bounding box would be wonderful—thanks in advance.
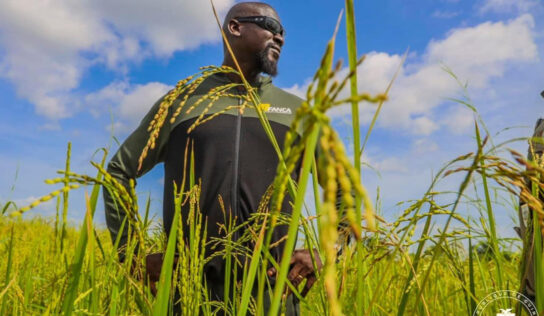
[104,2,321,309]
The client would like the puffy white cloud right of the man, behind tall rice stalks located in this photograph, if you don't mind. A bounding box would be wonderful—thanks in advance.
[304,14,538,135]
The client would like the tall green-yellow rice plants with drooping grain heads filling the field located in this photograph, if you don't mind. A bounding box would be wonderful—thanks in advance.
[0,0,544,315]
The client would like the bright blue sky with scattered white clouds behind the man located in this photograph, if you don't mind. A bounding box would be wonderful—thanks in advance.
[0,0,544,234]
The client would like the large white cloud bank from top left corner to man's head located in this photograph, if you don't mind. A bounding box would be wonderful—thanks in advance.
[0,0,233,120]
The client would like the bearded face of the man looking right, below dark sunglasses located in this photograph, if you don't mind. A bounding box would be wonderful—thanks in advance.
[240,7,284,76]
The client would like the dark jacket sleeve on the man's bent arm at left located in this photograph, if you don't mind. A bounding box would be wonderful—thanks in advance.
[103,97,170,261]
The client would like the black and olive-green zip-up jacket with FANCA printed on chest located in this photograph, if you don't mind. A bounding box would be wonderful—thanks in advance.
[104,74,308,294]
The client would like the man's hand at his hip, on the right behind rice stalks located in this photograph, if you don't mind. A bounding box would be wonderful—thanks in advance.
[268,249,323,296]
